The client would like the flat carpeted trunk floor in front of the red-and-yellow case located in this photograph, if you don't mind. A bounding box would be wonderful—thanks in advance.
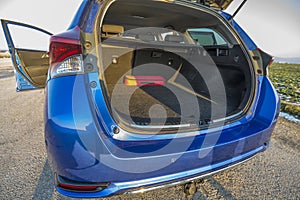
[108,83,237,125]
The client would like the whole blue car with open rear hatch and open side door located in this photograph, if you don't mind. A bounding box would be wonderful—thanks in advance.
[2,0,280,198]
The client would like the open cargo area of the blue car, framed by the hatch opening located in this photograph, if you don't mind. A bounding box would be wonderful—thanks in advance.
[101,0,253,133]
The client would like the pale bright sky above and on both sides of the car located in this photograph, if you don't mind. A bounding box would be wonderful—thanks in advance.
[0,0,300,58]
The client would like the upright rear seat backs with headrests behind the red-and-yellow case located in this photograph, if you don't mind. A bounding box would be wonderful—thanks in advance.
[101,25,210,94]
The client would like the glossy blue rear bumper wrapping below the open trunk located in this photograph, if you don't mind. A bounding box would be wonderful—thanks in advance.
[45,76,279,198]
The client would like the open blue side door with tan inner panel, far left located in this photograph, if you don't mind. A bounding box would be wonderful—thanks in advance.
[1,20,52,91]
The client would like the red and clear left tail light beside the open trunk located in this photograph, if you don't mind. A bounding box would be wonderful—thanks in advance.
[49,32,83,78]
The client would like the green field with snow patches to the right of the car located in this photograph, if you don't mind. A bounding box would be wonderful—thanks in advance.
[269,63,300,118]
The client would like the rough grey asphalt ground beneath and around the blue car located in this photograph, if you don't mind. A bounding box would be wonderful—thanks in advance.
[0,61,300,200]
